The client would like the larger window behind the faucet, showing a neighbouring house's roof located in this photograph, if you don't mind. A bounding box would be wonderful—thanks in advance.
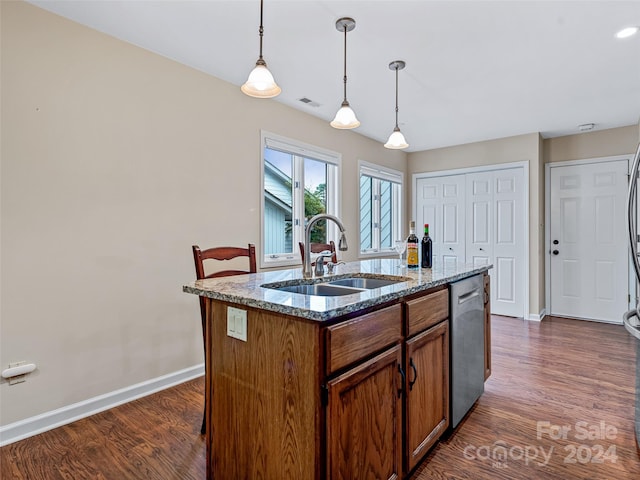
[261,132,340,267]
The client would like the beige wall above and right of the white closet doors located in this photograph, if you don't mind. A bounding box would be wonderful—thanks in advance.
[408,133,544,316]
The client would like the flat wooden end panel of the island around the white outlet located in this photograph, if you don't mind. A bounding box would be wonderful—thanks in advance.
[205,299,324,480]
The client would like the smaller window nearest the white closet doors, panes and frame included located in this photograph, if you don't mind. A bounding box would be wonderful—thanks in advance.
[359,161,403,255]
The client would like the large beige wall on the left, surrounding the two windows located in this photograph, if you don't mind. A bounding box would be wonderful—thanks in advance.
[0,2,406,425]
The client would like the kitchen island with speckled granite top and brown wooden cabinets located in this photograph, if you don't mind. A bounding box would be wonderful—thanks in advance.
[183,259,490,480]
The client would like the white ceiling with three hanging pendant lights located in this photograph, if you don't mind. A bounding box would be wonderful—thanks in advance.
[30,0,640,151]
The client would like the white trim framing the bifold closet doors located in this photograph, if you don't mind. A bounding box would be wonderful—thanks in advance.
[411,160,528,320]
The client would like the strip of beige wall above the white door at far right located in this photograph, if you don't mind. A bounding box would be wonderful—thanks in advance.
[544,125,638,163]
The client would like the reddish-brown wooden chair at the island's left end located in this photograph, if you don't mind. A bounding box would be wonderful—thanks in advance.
[192,243,257,433]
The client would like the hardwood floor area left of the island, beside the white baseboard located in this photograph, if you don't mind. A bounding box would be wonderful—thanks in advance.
[0,377,206,480]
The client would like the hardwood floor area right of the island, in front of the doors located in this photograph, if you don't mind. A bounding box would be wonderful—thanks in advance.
[413,316,640,480]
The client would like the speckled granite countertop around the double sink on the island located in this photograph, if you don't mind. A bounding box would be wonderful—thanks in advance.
[182,259,492,321]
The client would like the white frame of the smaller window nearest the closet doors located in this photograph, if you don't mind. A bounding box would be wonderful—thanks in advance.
[358,160,405,258]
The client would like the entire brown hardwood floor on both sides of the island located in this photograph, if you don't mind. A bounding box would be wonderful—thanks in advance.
[0,316,640,480]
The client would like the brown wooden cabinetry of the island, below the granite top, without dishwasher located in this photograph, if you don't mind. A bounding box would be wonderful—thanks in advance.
[205,277,484,480]
